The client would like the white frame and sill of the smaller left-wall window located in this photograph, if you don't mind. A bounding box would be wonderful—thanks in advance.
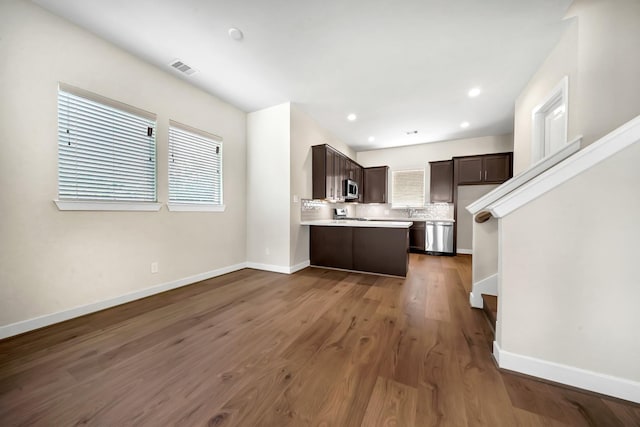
[167,120,226,212]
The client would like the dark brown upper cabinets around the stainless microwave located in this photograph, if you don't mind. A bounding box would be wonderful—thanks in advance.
[311,144,363,201]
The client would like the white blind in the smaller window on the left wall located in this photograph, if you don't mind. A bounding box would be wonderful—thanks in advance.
[169,121,222,206]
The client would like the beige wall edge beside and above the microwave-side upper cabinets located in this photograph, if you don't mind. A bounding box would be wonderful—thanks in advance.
[290,104,356,266]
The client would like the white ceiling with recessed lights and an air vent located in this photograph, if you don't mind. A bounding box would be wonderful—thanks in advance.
[33,0,571,151]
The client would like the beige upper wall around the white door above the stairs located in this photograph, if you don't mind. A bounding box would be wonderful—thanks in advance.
[514,0,640,174]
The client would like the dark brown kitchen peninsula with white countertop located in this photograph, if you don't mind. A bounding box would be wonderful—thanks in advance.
[301,219,412,277]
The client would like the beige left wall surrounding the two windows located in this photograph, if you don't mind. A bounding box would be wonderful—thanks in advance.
[0,1,246,326]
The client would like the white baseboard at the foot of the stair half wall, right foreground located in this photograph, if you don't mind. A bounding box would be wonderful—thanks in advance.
[493,341,640,403]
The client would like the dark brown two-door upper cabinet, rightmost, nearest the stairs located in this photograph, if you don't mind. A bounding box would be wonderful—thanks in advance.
[453,153,513,185]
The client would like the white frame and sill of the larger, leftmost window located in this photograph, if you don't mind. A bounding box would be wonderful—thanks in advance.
[54,82,162,211]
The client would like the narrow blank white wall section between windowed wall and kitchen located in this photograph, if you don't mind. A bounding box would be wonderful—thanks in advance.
[247,103,291,271]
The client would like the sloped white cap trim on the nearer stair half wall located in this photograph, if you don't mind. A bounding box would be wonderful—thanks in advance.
[486,116,640,218]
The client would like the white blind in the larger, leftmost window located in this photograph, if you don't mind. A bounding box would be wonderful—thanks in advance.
[58,84,156,202]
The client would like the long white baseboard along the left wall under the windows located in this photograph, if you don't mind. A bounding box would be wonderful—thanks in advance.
[0,262,247,339]
